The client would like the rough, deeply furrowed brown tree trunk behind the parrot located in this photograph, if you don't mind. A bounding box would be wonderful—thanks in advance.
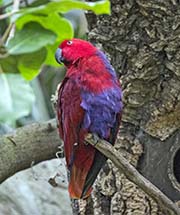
[74,0,180,215]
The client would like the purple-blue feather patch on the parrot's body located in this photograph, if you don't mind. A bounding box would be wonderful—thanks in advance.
[81,86,122,138]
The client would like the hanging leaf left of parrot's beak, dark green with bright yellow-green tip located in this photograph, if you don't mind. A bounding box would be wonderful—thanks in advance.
[18,48,47,81]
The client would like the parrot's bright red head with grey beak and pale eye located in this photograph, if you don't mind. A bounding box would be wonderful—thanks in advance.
[55,38,97,67]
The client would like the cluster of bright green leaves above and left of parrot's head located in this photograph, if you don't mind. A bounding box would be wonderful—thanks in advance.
[0,0,110,80]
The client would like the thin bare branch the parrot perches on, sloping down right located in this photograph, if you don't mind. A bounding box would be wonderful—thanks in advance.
[86,134,180,215]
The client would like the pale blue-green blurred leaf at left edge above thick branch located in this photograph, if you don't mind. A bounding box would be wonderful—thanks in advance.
[0,73,35,125]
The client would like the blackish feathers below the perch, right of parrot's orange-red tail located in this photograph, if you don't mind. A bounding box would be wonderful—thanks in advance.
[81,151,107,198]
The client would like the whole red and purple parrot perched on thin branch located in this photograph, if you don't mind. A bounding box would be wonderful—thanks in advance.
[55,38,122,199]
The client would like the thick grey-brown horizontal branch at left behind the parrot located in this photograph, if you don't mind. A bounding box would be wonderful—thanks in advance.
[0,120,63,183]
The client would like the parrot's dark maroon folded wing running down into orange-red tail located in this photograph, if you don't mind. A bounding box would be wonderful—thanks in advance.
[57,79,95,198]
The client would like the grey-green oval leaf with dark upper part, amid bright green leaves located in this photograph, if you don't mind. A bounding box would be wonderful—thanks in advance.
[7,22,56,55]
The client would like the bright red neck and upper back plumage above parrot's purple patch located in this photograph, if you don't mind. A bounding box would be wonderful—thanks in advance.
[66,55,119,93]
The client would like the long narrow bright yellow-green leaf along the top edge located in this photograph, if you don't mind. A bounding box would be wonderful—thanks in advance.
[12,0,110,21]
